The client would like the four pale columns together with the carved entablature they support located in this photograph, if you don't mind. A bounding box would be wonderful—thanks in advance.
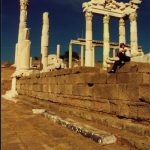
[82,0,144,69]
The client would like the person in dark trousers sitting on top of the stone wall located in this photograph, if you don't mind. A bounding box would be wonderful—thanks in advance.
[109,43,131,73]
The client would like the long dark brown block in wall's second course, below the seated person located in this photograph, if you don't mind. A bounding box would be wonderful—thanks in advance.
[117,73,143,84]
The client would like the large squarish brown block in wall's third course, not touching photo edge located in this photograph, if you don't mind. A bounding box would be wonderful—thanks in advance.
[118,83,139,101]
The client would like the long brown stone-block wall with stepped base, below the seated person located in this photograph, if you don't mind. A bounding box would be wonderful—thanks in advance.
[14,63,150,150]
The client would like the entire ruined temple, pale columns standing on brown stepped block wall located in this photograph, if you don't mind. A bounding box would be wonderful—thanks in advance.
[4,0,150,150]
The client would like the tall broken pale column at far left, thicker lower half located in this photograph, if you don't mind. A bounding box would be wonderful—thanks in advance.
[15,0,31,70]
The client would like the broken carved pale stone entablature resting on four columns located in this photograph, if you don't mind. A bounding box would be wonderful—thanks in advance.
[82,0,141,18]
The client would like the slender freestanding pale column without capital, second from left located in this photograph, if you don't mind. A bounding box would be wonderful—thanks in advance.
[41,12,49,71]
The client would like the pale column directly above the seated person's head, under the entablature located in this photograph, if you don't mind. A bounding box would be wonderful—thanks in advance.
[119,18,126,44]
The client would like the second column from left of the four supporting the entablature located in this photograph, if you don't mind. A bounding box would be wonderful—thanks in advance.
[103,15,110,69]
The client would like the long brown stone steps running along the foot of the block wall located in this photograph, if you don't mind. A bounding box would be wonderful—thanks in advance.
[18,96,150,150]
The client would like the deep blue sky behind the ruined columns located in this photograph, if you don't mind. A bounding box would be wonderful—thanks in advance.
[1,0,150,62]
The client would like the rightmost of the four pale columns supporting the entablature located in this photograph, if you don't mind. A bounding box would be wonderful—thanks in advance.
[129,12,138,54]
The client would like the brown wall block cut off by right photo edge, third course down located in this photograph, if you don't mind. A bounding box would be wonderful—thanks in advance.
[139,84,150,103]
